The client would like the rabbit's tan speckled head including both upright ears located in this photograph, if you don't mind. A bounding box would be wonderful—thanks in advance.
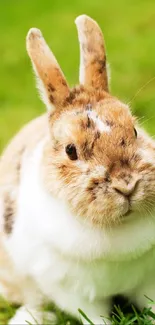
[27,15,155,227]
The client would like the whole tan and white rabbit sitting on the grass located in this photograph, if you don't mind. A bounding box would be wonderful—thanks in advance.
[0,15,155,324]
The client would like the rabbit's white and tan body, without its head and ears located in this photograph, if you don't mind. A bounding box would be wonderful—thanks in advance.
[0,115,155,317]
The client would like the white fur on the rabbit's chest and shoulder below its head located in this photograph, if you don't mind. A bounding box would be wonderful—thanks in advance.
[8,140,155,306]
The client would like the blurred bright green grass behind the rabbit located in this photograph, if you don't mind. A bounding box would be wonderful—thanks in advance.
[0,0,155,150]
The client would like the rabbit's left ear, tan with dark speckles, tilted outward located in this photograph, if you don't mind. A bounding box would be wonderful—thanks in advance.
[26,28,70,110]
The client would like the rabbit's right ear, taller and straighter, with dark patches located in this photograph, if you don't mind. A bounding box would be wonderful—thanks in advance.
[75,15,108,91]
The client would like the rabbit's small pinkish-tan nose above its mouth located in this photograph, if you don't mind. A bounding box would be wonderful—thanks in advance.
[112,179,138,196]
